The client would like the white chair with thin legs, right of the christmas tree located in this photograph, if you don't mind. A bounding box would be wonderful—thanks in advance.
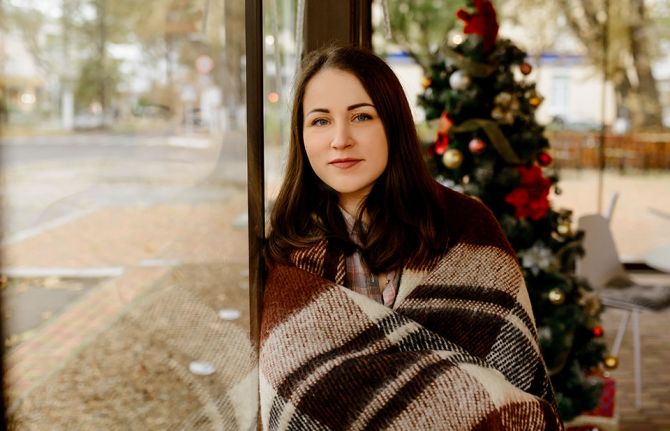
[577,196,670,409]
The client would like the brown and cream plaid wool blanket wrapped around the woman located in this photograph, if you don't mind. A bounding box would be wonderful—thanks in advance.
[259,190,562,431]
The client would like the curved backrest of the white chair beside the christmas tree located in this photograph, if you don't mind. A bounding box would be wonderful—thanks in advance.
[577,214,628,289]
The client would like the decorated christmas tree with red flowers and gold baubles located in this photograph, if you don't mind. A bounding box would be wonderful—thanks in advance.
[419,0,605,421]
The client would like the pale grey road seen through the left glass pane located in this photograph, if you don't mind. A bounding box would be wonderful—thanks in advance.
[0,133,246,242]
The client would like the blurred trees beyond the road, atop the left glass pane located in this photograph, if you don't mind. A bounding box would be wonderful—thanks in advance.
[2,0,249,130]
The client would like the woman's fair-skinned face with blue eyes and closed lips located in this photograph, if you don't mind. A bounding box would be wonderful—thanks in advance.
[302,69,388,214]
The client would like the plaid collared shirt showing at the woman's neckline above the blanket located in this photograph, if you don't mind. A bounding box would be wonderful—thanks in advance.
[340,208,400,307]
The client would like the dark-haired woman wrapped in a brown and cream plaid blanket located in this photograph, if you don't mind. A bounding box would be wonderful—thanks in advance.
[260,47,562,430]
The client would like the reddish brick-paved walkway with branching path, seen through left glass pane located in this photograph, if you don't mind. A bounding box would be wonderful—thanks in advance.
[0,191,248,400]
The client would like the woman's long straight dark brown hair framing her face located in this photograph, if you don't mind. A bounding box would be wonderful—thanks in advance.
[266,46,447,273]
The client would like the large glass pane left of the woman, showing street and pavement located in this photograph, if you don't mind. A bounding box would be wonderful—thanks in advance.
[0,0,256,430]
